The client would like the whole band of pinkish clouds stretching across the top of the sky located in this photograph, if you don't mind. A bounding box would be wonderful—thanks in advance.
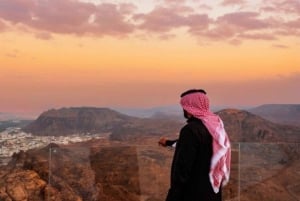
[0,0,300,44]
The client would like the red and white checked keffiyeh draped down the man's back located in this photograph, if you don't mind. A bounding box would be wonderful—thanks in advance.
[180,92,231,193]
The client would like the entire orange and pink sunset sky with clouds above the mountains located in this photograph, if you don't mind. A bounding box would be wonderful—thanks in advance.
[0,0,300,114]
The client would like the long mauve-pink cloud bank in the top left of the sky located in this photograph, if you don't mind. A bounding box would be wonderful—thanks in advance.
[0,0,134,35]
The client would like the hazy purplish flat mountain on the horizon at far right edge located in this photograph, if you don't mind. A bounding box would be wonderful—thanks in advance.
[248,104,300,127]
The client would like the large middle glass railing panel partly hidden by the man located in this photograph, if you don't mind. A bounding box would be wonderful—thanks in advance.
[48,145,239,201]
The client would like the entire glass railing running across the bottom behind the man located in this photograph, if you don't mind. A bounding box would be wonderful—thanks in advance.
[0,138,300,201]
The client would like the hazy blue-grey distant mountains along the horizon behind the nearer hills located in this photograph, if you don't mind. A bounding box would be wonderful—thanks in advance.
[0,104,300,126]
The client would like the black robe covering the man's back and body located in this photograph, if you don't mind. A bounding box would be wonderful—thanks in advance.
[167,118,222,201]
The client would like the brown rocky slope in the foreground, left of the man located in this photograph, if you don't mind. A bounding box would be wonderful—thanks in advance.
[0,144,172,201]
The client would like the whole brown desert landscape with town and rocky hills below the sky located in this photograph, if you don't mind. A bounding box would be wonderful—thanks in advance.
[0,105,300,201]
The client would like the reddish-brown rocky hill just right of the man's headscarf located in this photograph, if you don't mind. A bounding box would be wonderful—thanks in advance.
[217,109,300,143]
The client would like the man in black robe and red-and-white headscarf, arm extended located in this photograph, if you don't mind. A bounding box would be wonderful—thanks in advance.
[159,89,231,201]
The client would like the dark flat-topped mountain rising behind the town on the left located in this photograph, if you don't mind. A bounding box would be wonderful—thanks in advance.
[24,107,134,136]
